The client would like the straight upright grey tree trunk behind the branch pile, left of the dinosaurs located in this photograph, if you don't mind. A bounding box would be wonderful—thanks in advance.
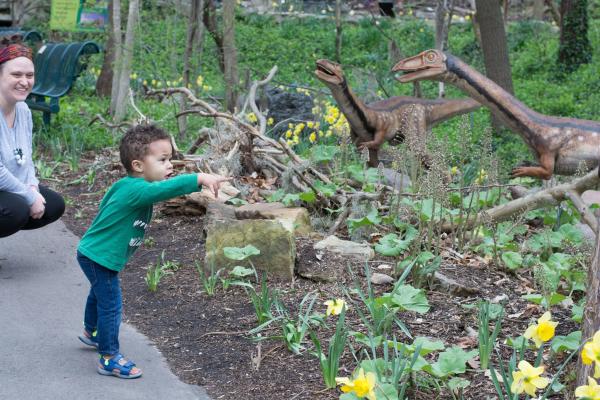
[223,0,239,113]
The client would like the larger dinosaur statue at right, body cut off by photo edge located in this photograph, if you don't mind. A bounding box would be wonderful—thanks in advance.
[392,50,600,179]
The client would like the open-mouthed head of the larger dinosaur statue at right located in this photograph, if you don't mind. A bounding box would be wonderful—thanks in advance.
[392,49,448,83]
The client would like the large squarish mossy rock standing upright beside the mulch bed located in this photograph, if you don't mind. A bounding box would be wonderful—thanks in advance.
[205,219,296,280]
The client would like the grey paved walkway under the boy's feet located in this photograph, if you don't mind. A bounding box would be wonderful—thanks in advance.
[0,221,209,400]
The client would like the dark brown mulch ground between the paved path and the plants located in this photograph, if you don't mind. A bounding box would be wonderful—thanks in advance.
[52,153,578,400]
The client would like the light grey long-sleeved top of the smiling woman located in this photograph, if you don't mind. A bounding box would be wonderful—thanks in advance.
[0,101,39,205]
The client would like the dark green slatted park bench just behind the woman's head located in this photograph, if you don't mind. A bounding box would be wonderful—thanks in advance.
[27,41,100,125]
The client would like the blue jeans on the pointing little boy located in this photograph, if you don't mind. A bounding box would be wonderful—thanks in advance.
[77,251,122,355]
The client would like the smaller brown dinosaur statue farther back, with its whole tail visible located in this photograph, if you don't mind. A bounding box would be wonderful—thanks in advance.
[315,60,481,167]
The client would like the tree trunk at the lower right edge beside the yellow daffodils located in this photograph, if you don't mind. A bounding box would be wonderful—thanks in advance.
[575,221,600,386]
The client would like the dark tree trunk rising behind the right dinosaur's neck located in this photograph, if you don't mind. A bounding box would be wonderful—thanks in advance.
[475,0,513,132]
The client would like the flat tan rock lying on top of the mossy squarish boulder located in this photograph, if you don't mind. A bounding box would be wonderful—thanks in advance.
[235,203,312,237]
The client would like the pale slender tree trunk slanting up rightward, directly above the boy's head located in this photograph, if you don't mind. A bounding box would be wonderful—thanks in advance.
[114,0,140,122]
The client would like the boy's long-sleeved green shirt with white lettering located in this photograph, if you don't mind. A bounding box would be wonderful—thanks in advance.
[78,174,200,271]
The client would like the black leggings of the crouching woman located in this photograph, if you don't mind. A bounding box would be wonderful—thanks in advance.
[0,186,65,237]
